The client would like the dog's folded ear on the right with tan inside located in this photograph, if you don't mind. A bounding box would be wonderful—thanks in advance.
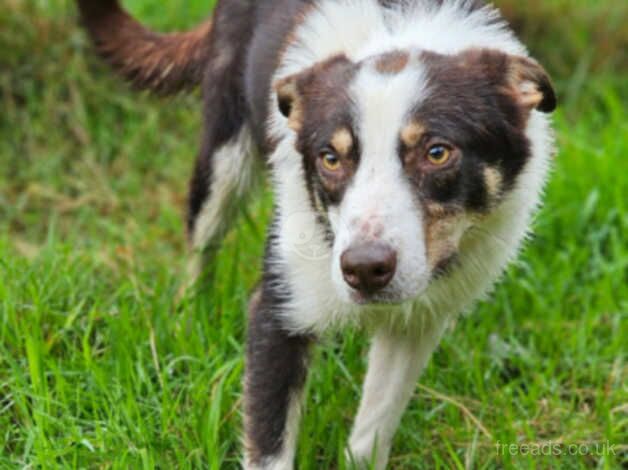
[507,56,557,113]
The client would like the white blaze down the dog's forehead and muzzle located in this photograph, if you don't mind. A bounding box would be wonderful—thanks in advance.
[330,61,427,295]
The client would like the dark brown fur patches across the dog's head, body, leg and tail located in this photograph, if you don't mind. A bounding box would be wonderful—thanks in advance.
[77,0,555,466]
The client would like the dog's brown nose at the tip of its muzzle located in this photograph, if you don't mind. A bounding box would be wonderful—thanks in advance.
[340,243,397,294]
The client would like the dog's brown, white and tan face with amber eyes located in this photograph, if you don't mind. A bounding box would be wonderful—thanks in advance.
[276,49,556,304]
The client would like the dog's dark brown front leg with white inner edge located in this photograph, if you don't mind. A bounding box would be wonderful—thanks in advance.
[244,287,311,470]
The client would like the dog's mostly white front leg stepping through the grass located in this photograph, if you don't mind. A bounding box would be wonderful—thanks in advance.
[349,320,444,470]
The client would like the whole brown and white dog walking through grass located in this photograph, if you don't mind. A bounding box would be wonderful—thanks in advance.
[78,0,556,469]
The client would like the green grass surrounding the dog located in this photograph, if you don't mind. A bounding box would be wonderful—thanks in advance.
[0,0,628,469]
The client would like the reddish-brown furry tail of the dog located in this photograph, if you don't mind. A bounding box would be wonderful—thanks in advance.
[77,0,211,94]
